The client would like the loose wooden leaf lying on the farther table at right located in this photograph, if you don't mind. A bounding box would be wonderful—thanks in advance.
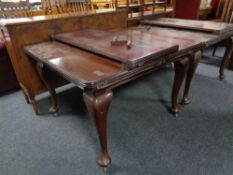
[141,18,233,35]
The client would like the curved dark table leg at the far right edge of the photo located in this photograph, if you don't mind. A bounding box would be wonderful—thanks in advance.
[219,38,232,80]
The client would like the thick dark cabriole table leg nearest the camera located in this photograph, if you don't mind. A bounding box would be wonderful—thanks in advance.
[83,90,112,168]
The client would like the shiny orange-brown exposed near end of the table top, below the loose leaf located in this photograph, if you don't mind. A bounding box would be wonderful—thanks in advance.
[25,41,126,89]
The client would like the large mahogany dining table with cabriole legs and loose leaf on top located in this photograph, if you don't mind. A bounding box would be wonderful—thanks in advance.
[24,26,217,168]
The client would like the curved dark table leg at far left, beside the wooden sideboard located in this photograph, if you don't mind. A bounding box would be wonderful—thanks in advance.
[36,62,58,114]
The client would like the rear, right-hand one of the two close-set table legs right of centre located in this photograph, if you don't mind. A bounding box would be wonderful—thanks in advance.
[181,51,202,105]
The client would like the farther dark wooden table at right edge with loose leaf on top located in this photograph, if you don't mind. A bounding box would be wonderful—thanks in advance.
[141,18,233,79]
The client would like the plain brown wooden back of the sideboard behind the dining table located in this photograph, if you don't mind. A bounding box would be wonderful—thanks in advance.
[0,11,127,95]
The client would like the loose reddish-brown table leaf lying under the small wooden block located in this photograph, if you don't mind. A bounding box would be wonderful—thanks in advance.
[53,29,178,69]
